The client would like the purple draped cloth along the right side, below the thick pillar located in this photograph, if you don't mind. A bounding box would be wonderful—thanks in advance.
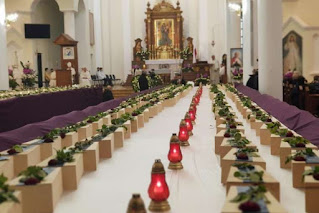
[236,84,319,146]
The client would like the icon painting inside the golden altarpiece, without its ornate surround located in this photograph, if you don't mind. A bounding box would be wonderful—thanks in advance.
[154,19,175,47]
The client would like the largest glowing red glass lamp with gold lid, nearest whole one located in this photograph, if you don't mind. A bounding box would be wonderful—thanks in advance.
[148,160,171,212]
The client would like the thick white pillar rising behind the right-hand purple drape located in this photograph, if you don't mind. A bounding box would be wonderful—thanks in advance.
[258,0,283,100]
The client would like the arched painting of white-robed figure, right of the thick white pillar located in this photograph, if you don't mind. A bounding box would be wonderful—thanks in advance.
[282,31,302,75]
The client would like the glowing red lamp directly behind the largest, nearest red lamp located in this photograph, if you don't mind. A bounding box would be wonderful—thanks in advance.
[167,134,183,170]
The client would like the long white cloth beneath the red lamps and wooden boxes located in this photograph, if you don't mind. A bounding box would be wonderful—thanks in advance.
[55,89,305,213]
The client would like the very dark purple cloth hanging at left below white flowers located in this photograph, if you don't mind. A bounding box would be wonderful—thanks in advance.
[0,88,103,133]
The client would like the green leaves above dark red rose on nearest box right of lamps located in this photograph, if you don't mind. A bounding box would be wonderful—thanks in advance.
[231,185,270,203]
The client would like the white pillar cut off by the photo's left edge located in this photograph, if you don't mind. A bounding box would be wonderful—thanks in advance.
[0,0,9,90]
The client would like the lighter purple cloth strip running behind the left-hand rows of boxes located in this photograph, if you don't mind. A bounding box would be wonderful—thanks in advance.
[0,86,163,151]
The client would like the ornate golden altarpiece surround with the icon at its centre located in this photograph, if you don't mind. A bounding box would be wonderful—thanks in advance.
[145,0,184,60]
